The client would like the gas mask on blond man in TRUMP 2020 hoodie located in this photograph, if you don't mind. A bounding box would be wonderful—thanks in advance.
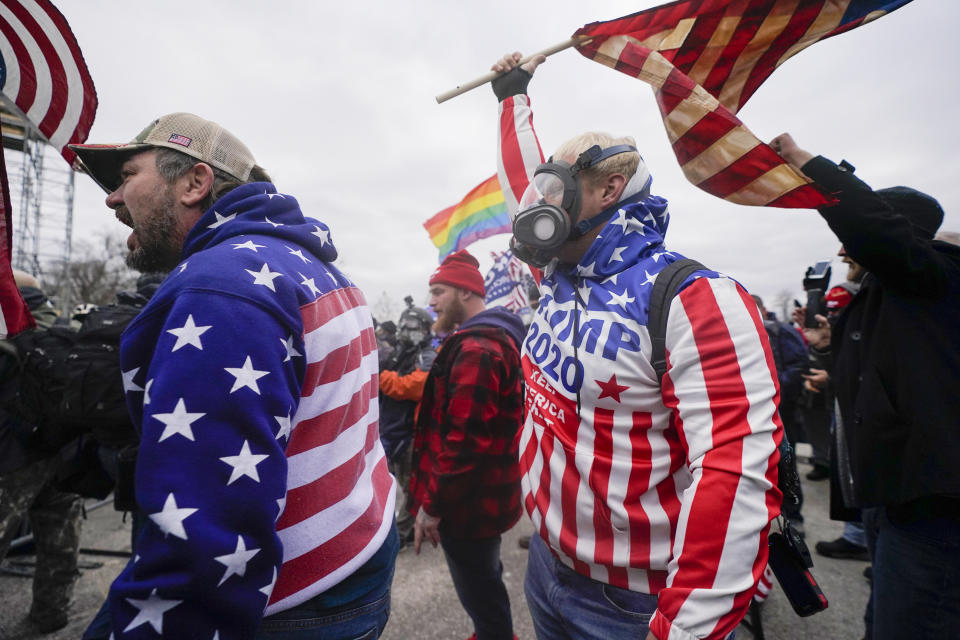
[510,144,649,269]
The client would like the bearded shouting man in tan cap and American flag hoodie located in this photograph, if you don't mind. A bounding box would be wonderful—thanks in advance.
[74,113,398,640]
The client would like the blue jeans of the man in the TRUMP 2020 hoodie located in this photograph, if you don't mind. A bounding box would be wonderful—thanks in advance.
[523,534,733,640]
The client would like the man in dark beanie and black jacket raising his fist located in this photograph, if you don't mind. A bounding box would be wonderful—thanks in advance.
[770,134,960,640]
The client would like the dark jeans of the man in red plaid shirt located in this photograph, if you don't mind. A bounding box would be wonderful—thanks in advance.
[440,532,513,640]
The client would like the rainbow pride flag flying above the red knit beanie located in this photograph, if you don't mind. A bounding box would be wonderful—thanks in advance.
[423,175,513,262]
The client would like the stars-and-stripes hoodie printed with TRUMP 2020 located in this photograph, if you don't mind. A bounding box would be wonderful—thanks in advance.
[500,95,782,640]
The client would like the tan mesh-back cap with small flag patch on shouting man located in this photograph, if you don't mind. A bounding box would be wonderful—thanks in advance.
[70,113,256,193]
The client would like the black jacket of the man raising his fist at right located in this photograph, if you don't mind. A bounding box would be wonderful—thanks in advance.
[802,157,960,507]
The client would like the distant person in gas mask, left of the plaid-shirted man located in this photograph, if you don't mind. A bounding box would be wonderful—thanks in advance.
[380,296,437,549]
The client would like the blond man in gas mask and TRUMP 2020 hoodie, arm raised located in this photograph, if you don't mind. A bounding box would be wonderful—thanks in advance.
[493,54,782,640]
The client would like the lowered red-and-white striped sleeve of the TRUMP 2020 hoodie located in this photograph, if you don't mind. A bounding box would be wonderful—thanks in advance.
[650,277,783,640]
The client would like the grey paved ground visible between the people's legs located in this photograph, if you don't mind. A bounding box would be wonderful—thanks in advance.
[0,449,869,640]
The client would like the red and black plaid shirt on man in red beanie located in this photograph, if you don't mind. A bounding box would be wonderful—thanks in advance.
[410,326,523,538]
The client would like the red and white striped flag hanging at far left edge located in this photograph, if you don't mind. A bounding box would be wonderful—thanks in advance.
[0,0,97,337]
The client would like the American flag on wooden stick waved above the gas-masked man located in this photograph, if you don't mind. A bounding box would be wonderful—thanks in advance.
[574,0,910,208]
